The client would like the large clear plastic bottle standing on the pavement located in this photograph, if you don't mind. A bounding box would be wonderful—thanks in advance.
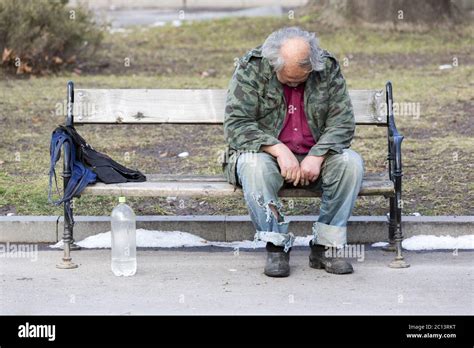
[111,197,137,276]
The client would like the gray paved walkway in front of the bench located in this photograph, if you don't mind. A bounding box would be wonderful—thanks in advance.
[0,247,474,314]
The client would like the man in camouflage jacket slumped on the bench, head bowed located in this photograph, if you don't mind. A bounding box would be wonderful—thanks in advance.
[224,27,364,277]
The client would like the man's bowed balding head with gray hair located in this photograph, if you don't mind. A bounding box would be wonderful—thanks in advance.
[262,27,322,86]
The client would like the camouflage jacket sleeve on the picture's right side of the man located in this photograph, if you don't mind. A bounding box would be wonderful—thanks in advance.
[308,58,355,156]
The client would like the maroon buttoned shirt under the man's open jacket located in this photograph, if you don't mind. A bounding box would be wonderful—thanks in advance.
[278,83,316,155]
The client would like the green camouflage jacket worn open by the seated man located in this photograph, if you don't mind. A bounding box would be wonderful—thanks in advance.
[223,46,355,185]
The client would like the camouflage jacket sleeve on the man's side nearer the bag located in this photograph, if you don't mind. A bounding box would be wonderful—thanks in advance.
[224,62,280,152]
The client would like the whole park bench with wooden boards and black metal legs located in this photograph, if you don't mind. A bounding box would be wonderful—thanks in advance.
[58,81,408,268]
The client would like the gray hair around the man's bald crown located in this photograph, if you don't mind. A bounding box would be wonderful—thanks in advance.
[262,27,324,71]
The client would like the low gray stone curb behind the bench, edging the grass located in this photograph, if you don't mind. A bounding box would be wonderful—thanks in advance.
[0,215,474,243]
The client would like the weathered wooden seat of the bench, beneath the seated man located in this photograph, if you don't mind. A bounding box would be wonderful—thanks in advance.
[82,173,393,198]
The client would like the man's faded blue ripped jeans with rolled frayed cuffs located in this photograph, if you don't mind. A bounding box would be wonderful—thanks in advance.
[237,149,364,252]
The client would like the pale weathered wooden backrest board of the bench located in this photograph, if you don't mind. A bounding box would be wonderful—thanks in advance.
[74,89,386,125]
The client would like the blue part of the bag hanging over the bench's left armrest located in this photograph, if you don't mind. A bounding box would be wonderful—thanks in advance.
[48,126,97,223]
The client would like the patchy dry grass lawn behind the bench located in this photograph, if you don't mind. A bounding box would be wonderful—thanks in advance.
[0,18,474,215]
